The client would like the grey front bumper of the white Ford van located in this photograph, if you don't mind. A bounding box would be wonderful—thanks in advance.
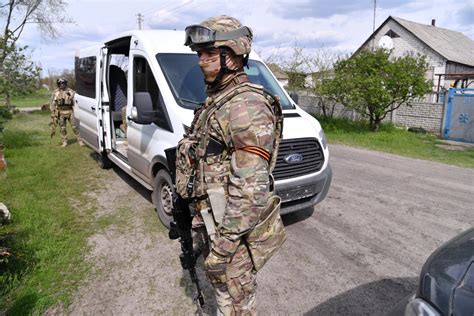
[275,164,332,214]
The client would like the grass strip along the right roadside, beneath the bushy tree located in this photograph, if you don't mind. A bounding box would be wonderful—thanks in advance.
[318,117,474,168]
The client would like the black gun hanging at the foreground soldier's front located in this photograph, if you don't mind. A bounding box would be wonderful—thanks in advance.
[165,147,204,307]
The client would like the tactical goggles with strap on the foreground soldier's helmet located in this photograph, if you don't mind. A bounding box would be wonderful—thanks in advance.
[184,25,252,46]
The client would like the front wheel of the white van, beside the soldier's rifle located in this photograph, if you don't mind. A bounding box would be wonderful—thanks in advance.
[151,169,173,229]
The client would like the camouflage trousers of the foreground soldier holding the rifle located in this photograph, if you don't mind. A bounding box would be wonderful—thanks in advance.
[193,226,257,316]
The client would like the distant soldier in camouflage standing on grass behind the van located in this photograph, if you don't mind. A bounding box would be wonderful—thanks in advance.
[50,78,84,147]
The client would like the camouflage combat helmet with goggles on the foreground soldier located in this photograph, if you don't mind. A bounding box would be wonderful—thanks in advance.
[184,15,253,55]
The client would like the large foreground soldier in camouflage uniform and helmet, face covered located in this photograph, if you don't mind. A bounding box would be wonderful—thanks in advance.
[182,16,282,315]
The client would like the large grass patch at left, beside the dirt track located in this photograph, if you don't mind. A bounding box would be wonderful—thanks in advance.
[0,112,103,315]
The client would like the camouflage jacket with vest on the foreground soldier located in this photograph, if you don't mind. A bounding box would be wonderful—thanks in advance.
[190,82,283,256]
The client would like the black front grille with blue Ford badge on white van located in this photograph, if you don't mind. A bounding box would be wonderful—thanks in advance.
[273,138,324,180]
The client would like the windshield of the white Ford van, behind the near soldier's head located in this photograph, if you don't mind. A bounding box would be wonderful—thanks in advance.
[156,54,293,110]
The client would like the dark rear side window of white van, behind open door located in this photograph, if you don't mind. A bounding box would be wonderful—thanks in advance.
[75,56,96,99]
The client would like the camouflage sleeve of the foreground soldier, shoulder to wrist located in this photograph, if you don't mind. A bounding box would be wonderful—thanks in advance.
[214,93,274,255]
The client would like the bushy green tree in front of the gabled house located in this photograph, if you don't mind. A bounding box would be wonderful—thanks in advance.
[321,49,431,131]
